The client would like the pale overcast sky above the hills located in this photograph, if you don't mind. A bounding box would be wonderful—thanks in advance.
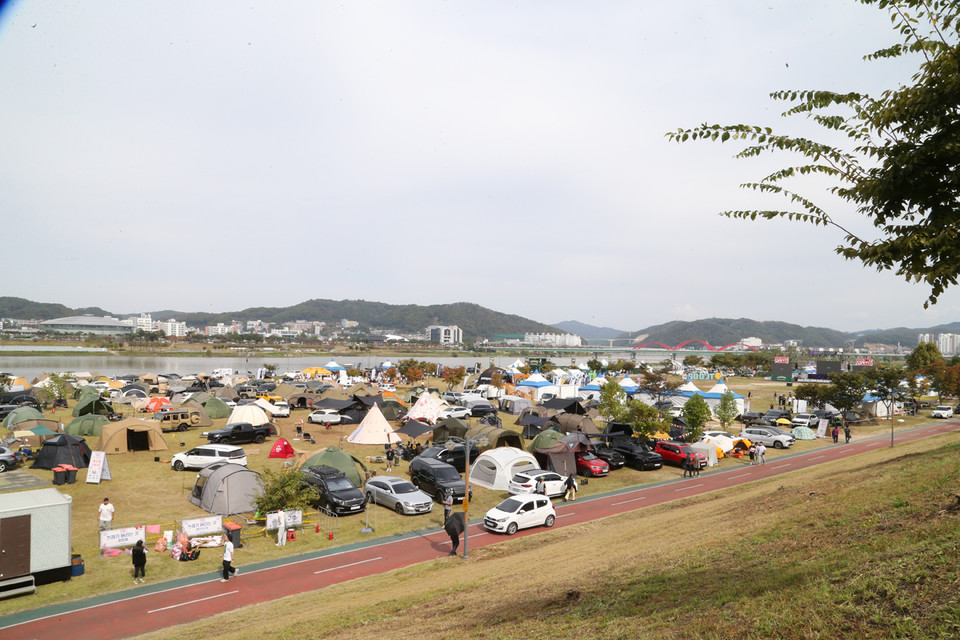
[0,0,960,331]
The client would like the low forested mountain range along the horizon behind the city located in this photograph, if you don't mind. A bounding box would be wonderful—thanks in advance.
[0,297,960,348]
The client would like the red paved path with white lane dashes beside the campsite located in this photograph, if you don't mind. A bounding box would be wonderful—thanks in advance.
[0,420,960,640]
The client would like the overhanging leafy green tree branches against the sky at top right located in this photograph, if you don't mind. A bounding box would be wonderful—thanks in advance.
[667,0,960,307]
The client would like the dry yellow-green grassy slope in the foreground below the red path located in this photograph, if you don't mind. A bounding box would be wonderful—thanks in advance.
[135,435,960,640]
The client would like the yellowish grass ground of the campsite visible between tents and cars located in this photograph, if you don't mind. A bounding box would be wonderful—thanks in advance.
[0,379,940,615]
